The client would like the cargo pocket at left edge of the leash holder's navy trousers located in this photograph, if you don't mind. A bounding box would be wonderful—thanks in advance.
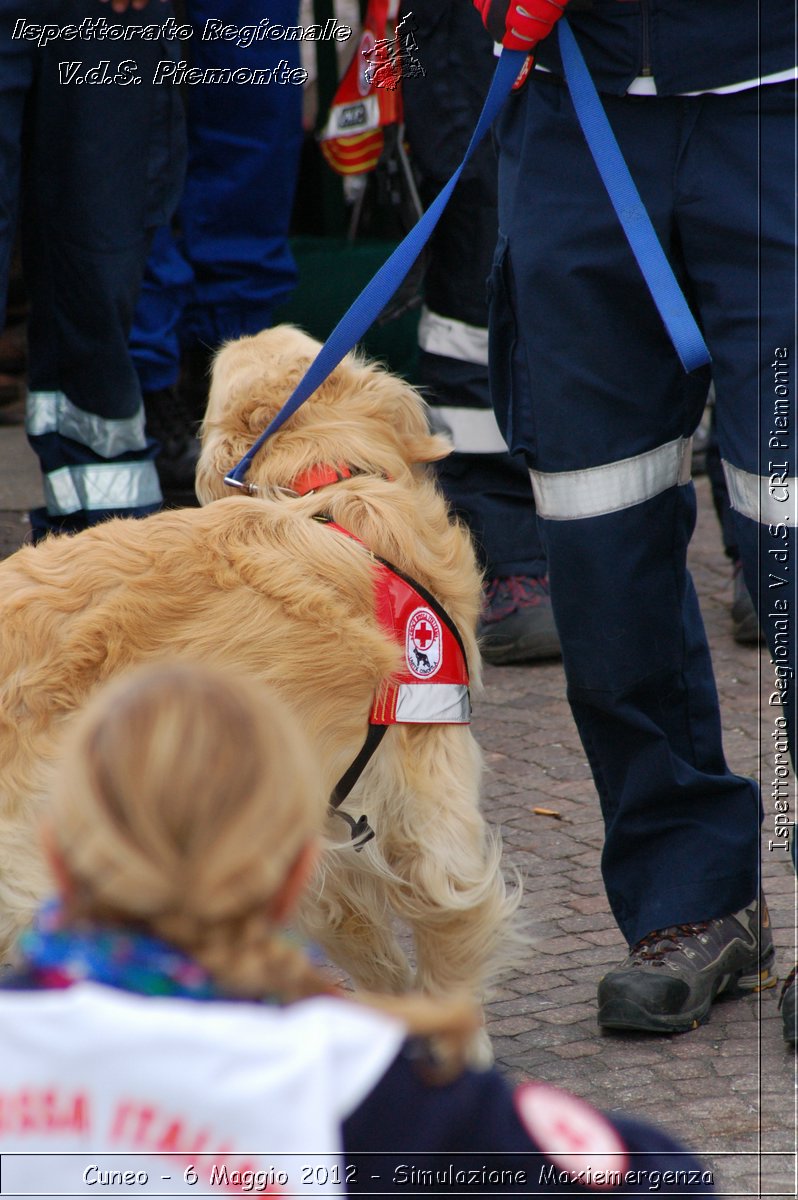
[487,234,534,454]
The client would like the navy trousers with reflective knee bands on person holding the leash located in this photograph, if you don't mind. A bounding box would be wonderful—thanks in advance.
[491,77,798,943]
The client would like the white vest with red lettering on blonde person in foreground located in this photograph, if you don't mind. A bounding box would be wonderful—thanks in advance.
[0,983,406,1196]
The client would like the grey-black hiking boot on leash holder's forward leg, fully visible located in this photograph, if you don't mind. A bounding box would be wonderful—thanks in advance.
[599,900,776,1033]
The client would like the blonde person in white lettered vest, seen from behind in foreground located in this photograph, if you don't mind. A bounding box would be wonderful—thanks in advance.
[0,664,712,1195]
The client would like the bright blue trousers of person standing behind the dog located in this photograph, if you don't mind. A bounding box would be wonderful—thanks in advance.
[131,0,302,391]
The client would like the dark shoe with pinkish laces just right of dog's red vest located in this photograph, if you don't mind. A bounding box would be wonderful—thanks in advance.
[478,575,560,666]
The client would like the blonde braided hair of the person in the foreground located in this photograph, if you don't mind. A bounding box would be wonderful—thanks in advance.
[53,664,329,998]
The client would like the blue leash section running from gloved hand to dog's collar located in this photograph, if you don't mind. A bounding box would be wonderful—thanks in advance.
[224,50,527,487]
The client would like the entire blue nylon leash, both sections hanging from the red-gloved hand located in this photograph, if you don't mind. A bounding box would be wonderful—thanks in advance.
[224,18,710,487]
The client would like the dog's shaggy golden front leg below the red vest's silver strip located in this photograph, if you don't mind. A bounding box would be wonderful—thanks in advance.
[316,726,530,998]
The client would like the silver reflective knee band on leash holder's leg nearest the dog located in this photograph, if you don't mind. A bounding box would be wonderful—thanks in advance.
[529,438,692,521]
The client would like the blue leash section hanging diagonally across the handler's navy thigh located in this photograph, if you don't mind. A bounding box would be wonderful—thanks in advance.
[557,19,712,372]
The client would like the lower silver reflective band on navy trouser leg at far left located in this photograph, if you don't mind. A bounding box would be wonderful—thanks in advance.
[43,462,162,516]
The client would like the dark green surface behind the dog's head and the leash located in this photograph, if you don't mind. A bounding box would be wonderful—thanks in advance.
[275,236,419,380]
